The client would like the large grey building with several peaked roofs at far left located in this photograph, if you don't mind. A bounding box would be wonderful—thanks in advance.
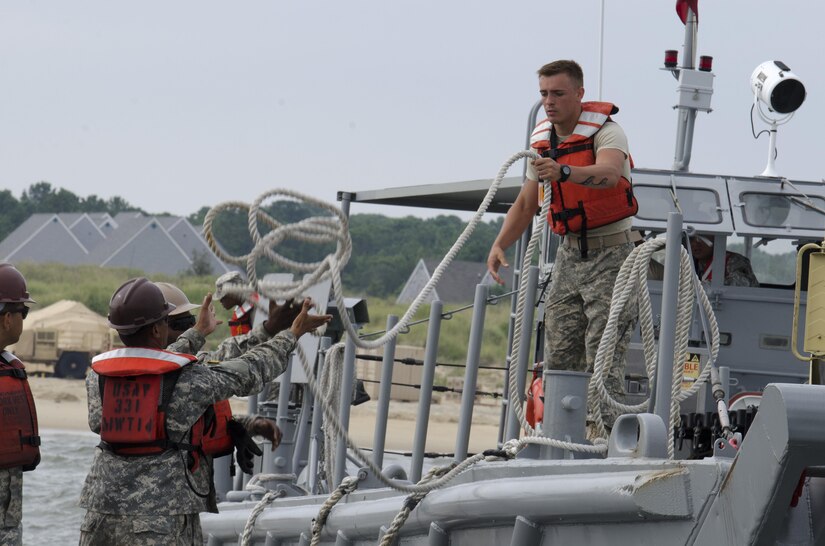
[0,212,234,275]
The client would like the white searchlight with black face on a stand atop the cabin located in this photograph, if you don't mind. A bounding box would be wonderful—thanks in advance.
[751,61,805,178]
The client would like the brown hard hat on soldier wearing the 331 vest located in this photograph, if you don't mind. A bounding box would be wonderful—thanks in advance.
[109,277,175,334]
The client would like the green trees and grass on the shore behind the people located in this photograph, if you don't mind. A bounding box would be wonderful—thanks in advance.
[6,182,520,366]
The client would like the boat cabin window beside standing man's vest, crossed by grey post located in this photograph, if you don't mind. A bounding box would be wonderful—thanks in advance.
[633,184,722,224]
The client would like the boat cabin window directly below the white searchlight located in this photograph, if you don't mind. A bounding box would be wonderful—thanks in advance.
[741,192,825,229]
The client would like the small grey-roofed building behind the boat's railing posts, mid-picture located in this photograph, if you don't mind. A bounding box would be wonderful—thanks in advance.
[395,260,495,303]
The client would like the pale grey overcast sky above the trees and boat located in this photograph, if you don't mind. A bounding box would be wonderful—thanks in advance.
[0,0,825,216]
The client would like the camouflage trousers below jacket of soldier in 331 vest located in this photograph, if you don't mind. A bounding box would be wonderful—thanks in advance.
[80,511,203,546]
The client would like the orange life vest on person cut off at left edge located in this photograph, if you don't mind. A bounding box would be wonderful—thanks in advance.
[0,351,40,470]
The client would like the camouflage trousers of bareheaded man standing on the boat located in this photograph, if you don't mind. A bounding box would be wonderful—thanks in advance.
[544,243,637,426]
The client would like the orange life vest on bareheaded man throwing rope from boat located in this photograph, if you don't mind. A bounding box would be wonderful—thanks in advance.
[530,102,639,245]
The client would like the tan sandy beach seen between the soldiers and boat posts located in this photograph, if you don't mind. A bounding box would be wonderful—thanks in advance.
[29,377,500,453]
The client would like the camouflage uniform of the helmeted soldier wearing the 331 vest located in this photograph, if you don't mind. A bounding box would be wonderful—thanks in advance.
[80,330,296,546]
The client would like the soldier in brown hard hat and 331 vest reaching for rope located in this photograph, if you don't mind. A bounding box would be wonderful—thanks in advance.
[80,278,331,546]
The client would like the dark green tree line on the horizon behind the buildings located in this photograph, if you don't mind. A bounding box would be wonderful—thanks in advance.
[0,182,503,297]
